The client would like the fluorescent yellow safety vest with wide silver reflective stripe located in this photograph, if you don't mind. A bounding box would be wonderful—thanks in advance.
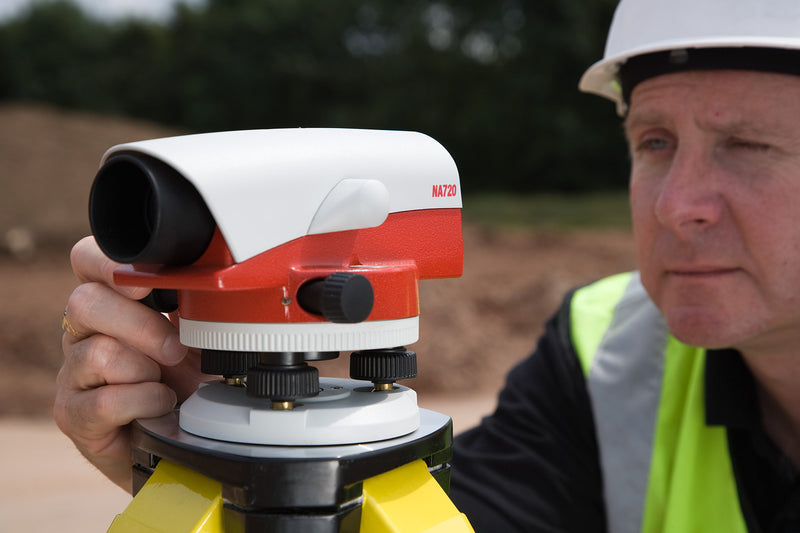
[570,273,747,533]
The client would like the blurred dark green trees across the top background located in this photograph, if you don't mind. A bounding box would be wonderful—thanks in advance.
[0,0,627,192]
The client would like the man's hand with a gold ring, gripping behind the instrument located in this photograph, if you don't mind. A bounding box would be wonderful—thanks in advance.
[53,237,203,491]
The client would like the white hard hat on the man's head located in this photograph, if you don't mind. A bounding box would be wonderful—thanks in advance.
[579,0,800,113]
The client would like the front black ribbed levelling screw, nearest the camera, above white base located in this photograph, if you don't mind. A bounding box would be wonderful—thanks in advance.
[247,363,319,402]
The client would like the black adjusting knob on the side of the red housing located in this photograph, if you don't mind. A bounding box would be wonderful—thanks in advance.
[297,272,375,324]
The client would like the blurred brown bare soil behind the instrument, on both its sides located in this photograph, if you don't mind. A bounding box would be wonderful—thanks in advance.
[0,105,634,416]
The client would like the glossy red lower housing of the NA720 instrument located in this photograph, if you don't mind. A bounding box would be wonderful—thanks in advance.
[114,208,463,324]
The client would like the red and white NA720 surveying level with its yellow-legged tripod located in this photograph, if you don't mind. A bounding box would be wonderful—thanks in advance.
[89,129,472,533]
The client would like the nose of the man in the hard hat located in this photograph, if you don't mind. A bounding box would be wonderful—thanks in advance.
[655,146,722,233]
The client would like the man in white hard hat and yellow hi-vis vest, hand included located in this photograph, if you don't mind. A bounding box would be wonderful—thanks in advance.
[54,0,800,533]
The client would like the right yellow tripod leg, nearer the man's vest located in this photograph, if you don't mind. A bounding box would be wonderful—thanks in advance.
[361,460,473,533]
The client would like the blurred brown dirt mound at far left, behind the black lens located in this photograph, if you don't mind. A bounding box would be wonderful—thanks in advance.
[0,105,177,258]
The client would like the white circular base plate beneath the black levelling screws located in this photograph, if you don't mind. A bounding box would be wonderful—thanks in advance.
[180,377,419,446]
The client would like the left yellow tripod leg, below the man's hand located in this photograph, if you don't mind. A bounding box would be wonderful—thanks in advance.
[108,460,223,533]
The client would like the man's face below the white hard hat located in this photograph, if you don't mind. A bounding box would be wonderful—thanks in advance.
[625,71,800,353]
